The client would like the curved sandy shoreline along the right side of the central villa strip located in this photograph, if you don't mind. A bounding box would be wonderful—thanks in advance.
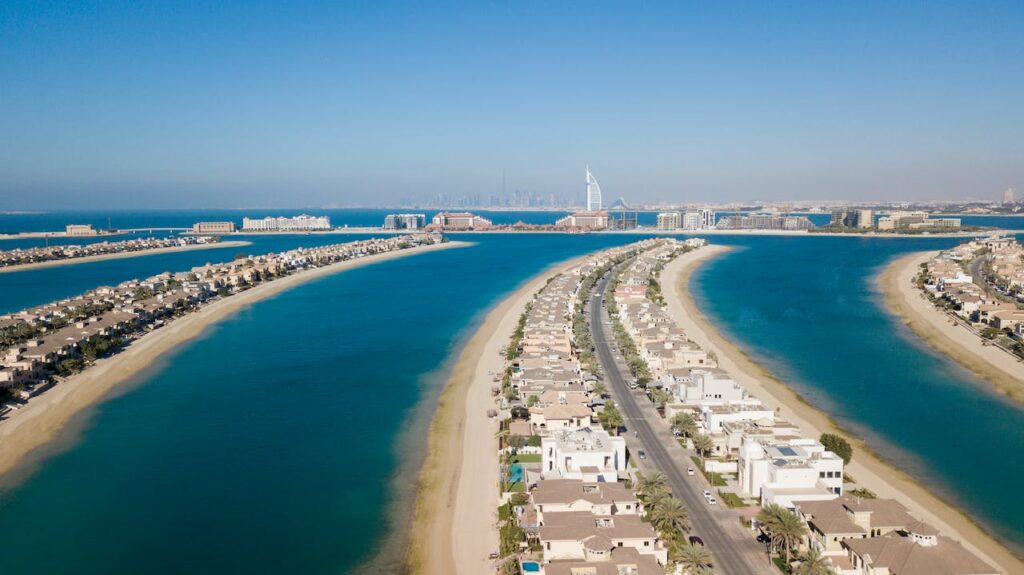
[662,246,1024,573]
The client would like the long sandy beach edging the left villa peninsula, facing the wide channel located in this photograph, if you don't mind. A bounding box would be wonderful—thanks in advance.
[0,241,469,475]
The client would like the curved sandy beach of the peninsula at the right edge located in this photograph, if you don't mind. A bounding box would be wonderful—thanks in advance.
[878,252,1024,402]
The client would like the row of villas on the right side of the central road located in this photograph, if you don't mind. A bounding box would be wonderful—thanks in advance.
[614,239,997,575]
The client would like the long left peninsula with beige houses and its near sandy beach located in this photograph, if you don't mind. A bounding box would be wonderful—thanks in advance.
[0,234,467,474]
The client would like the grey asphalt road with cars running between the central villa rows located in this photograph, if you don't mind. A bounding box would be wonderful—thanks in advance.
[588,270,774,575]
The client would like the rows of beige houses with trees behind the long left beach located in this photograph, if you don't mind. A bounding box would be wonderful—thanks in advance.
[0,234,443,405]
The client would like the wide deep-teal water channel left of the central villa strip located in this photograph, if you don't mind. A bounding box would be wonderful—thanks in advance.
[0,235,643,574]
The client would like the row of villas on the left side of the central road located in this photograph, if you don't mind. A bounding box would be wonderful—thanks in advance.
[496,240,669,575]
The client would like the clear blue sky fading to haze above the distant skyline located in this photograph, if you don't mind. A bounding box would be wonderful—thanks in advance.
[0,0,1024,210]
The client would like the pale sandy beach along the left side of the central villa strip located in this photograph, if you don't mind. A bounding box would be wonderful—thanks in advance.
[409,254,580,575]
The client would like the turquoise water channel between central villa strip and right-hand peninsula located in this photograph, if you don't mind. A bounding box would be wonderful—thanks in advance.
[691,237,1024,549]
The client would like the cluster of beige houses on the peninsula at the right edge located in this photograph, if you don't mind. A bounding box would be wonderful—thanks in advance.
[922,237,1024,338]
